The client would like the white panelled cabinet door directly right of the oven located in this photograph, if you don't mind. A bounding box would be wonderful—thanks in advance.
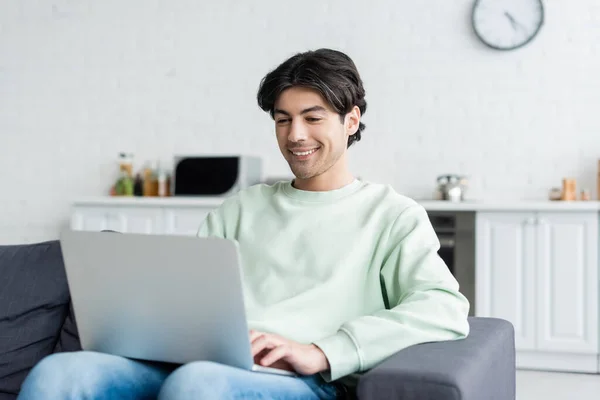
[475,212,536,350]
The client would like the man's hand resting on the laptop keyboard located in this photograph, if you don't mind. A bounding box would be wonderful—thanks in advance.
[250,330,329,375]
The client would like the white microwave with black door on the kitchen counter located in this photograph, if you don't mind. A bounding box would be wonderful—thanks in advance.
[171,155,262,197]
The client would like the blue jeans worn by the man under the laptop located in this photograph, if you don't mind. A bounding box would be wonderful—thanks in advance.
[18,351,339,400]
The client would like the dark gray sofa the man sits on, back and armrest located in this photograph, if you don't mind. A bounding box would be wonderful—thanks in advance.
[0,241,515,400]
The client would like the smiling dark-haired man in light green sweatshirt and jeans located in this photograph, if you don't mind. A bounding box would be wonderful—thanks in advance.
[20,49,469,400]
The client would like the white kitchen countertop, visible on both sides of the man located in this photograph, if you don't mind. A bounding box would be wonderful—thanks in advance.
[73,196,600,212]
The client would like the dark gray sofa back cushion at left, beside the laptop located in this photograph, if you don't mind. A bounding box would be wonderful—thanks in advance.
[0,241,70,398]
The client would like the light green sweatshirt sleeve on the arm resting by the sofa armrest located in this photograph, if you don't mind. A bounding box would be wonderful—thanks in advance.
[314,205,469,381]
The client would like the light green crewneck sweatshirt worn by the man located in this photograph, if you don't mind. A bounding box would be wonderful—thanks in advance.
[198,180,469,381]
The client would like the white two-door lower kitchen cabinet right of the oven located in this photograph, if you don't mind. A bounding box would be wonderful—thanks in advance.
[475,211,599,372]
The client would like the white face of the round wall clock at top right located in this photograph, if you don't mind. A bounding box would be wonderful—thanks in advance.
[473,0,544,50]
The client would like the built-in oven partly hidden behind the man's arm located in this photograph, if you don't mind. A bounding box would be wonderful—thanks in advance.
[428,211,477,316]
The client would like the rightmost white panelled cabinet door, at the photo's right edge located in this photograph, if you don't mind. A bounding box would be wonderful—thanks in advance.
[536,213,598,353]
